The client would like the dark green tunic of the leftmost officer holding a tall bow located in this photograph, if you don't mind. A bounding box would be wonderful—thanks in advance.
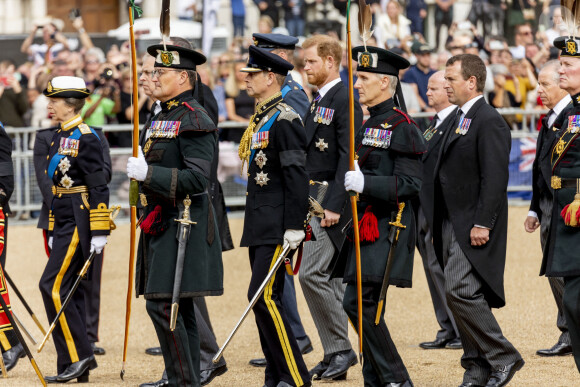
[136,90,223,299]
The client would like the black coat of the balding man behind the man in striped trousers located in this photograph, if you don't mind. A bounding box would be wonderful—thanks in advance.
[415,108,457,230]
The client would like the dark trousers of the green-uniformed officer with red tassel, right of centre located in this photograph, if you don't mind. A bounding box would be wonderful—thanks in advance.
[342,283,412,387]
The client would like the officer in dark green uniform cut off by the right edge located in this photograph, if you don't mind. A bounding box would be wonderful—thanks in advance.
[540,36,580,370]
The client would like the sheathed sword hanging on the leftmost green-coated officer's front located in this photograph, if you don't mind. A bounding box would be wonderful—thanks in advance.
[169,195,197,332]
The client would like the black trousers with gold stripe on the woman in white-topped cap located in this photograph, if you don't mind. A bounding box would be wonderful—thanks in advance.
[39,205,93,374]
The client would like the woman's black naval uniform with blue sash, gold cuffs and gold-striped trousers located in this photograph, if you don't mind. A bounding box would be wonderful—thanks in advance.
[39,115,110,374]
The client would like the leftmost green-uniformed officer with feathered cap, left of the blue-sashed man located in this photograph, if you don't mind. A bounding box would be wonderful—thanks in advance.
[127,45,223,386]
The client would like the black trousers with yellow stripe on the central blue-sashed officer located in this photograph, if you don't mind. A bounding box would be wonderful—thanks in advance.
[248,245,310,387]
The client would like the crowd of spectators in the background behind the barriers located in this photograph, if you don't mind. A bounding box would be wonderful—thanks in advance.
[0,0,565,165]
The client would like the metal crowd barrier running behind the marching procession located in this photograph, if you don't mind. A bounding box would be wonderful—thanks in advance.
[6,108,547,222]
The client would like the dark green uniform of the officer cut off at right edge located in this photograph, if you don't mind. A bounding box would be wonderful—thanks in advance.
[540,93,580,370]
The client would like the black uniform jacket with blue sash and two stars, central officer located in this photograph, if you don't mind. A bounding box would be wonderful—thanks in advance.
[240,96,308,246]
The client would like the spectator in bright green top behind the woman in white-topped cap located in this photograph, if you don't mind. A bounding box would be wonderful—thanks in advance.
[81,66,121,127]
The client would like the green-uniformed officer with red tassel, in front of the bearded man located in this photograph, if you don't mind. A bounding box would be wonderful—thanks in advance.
[343,47,427,387]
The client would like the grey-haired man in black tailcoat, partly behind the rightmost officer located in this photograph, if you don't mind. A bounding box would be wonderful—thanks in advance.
[524,60,572,356]
